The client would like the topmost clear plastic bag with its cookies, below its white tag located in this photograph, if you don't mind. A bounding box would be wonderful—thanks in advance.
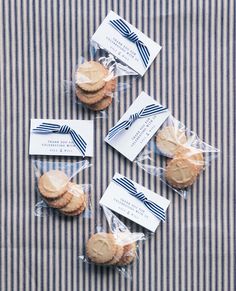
[64,41,138,117]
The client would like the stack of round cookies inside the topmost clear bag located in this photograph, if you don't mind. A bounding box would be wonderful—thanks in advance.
[75,61,116,111]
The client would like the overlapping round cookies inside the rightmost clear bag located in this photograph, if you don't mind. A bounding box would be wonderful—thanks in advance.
[156,126,205,189]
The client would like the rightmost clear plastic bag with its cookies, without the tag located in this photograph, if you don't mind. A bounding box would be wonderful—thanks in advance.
[135,116,219,198]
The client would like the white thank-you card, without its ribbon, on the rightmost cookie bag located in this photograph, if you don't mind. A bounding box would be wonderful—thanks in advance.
[105,92,170,161]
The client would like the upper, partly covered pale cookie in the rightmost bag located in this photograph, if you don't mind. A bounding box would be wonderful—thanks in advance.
[156,126,187,158]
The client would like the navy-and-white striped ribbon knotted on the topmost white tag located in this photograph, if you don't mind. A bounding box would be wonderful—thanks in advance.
[110,19,150,67]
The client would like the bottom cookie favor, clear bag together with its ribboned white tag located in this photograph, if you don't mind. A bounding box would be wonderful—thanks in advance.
[80,173,170,278]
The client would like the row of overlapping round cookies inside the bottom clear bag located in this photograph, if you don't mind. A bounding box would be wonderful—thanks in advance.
[86,232,137,266]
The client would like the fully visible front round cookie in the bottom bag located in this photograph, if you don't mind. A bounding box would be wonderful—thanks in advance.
[86,232,117,264]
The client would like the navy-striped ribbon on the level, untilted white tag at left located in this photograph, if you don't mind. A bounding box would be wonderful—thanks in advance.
[33,122,87,157]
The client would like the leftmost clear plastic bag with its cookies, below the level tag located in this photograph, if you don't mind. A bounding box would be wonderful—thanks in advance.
[33,160,92,218]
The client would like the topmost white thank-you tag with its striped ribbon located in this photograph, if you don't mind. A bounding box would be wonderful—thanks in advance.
[92,11,161,76]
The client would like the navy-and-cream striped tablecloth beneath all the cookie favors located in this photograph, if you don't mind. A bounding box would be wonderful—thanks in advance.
[0,0,236,291]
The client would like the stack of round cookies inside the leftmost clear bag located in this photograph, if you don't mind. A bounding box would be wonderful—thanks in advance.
[38,170,87,216]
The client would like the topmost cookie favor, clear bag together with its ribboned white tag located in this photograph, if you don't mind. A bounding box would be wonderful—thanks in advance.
[73,11,161,111]
